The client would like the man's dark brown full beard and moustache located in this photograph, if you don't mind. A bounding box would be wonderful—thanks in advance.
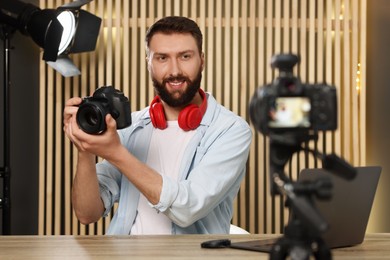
[152,70,202,107]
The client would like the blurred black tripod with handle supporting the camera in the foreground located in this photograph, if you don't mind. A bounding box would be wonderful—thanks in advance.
[270,132,355,260]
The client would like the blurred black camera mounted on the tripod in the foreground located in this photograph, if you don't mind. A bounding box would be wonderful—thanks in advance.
[249,54,337,134]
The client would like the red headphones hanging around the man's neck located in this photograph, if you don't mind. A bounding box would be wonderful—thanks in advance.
[149,89,207,131]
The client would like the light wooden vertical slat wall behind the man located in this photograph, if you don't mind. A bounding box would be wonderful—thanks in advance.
[39,0,366,235]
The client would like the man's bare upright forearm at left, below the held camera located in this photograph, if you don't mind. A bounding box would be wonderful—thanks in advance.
[72,152,104,224]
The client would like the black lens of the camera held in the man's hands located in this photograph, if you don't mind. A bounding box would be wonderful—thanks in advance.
[76,103,107,134]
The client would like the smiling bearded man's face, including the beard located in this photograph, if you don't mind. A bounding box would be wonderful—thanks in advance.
[147,33,204,107]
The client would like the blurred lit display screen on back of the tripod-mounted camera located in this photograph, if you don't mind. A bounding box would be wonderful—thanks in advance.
[269,97,311,128]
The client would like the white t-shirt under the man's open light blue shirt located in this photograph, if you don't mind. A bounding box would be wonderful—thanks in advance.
[131,121,195,235]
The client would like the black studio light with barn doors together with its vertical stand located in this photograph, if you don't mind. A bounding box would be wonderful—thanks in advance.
[0,0,101,235]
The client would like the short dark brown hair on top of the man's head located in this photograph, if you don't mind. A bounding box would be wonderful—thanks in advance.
[145,16,203,54]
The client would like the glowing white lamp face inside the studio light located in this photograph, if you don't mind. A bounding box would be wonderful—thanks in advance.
[57,11,76,55]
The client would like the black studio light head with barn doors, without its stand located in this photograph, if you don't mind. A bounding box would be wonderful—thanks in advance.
[0,0,101,76]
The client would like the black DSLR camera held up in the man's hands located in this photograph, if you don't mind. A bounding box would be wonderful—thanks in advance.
[76,86,131,134]
